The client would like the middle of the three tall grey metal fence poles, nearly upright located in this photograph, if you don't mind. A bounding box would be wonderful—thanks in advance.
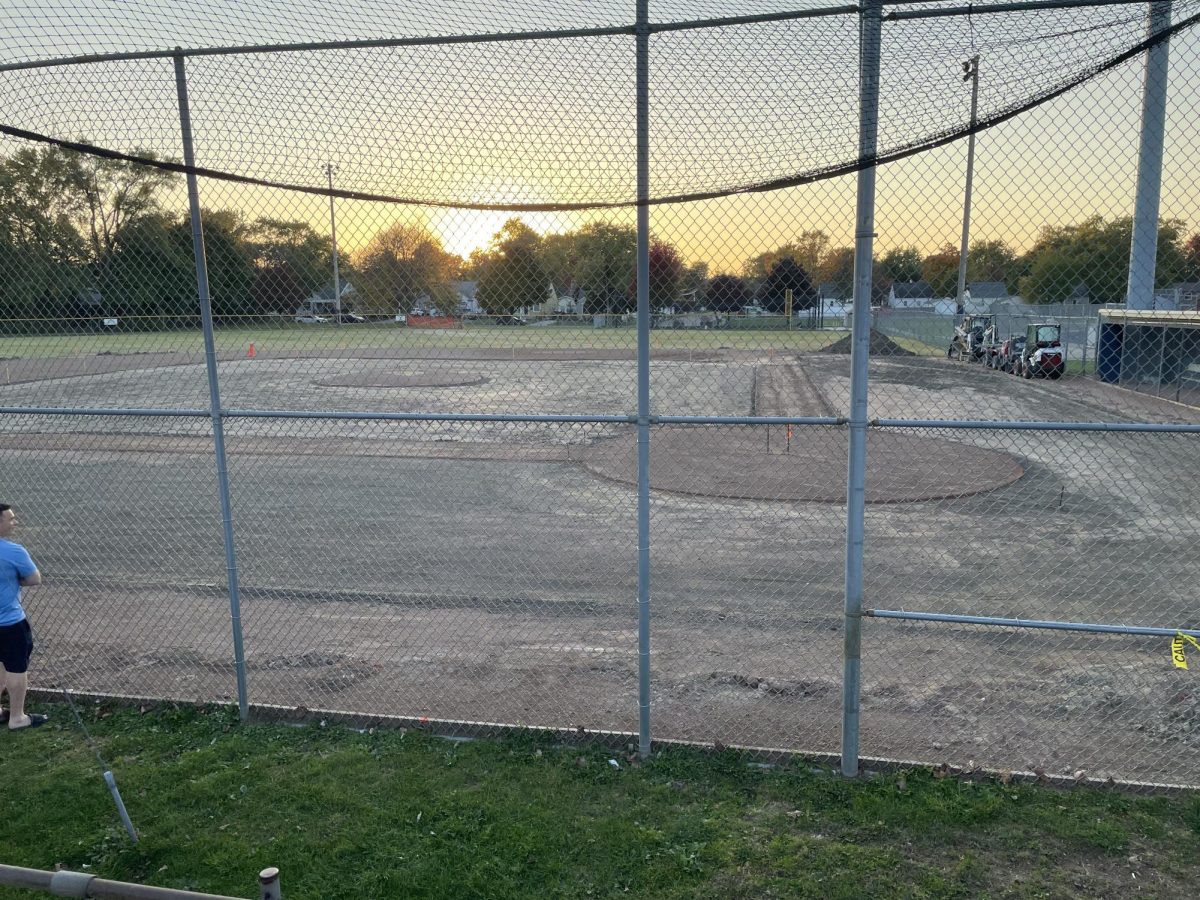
[636,0,650,758]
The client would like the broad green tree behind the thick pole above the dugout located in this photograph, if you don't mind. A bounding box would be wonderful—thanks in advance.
[1020,216,1186,304]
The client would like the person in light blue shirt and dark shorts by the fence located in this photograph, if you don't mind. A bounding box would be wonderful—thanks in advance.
[0,503,46,731]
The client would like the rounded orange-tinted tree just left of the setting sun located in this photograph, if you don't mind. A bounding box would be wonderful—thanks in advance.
[354,222,458,313]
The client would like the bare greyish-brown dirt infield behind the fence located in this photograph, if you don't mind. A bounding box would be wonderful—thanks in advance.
[0,350,1200,784]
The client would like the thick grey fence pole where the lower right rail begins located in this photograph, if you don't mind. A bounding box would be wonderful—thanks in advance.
[841,0,883,776]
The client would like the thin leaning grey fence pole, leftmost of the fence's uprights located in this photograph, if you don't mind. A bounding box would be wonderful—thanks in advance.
[175,48,250,720]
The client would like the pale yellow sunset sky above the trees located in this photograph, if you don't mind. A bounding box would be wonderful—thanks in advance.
[0,5,1200,272]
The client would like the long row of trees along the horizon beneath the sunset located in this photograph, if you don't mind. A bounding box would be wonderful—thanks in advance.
[0,148,1200,330]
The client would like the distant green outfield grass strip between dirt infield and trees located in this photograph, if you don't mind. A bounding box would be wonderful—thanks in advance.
[0,322,845,359]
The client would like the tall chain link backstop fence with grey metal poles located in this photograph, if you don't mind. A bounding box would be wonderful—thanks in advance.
[0,0,1200,787]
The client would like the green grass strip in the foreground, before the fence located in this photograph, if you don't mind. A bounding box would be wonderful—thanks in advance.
[0,706,1200,900]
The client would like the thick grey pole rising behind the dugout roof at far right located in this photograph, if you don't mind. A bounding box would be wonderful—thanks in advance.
[1126,0,1171,310]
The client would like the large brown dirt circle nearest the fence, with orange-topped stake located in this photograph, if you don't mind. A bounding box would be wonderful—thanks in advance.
[582,425,1025,503]
